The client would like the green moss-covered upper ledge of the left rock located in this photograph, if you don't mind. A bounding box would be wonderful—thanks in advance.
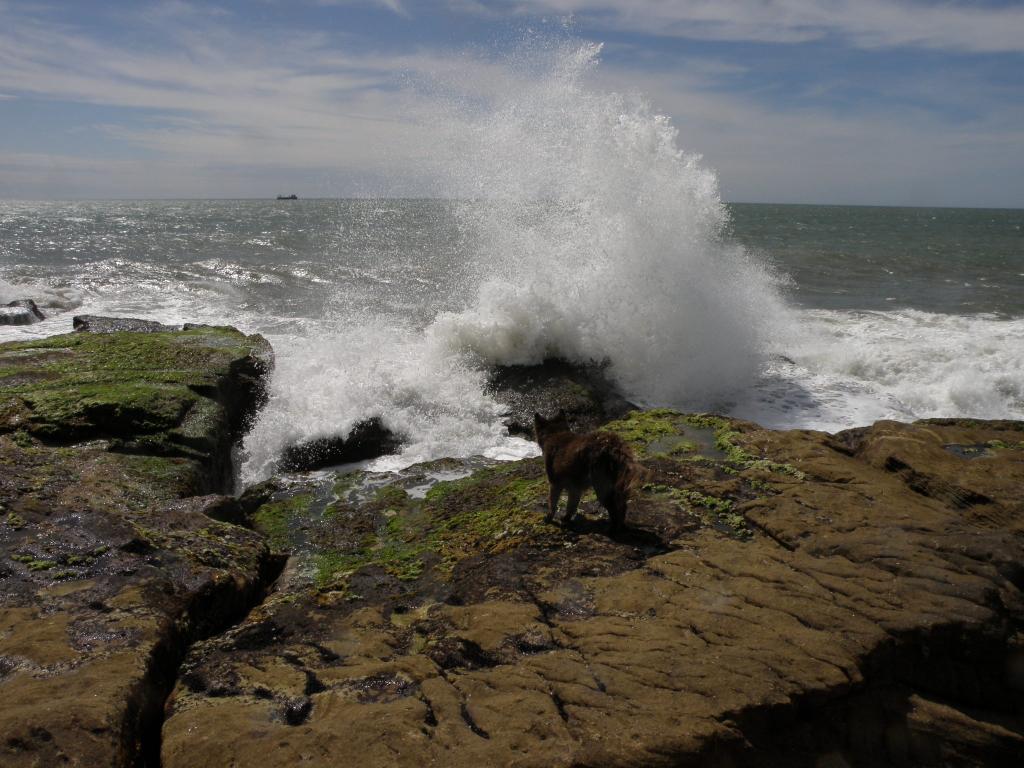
[0,328,269,442]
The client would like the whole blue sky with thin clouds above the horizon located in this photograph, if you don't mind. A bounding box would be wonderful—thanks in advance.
[0,0,1024,208]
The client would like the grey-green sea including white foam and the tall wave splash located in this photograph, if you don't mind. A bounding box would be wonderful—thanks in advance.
[0,43,1024,481]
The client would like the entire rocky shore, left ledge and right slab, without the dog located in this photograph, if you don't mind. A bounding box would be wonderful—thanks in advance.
[0,318,1024,767]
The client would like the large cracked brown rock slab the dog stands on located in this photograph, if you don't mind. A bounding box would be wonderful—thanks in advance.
[162,411,1024,766]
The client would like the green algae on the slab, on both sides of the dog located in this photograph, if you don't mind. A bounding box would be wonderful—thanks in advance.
[243,409,786,597]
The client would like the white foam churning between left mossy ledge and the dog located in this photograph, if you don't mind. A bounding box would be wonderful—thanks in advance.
[234,318,537,481]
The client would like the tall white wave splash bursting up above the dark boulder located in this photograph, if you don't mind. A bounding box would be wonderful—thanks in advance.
[428,40,788,408]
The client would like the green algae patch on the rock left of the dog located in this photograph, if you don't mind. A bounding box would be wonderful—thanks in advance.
[245,462,547,591]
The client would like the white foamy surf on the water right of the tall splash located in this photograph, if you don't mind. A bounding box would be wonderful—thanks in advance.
[730,309,1024,431]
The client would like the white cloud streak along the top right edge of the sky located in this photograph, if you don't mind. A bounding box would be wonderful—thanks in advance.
[477,0,1024,52]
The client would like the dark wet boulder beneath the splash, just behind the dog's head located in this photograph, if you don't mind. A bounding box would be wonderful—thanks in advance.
[488,357,637,437]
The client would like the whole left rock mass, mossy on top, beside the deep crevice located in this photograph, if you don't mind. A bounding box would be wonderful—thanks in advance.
[0,329,280,766]
